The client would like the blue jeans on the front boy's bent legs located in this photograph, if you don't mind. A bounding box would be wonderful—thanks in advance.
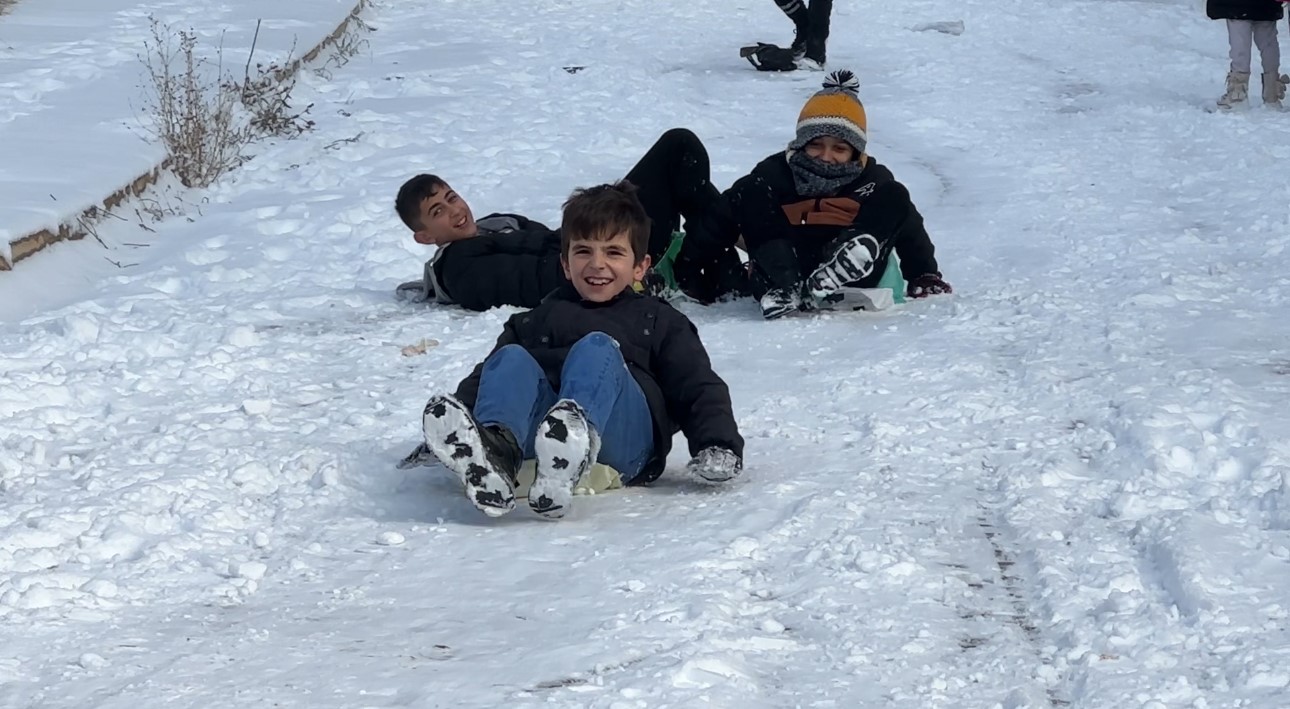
[475,333,654,482]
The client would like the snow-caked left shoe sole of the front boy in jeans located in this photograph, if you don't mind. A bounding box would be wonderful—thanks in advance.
[422,397,515,517]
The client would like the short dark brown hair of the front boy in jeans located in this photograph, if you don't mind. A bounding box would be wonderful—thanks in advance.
[560,179,650,263]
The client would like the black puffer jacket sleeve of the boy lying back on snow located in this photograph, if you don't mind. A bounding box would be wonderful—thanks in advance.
[436,231,565,311]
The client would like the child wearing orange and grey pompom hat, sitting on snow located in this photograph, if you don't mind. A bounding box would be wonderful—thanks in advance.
[725,70,951,320]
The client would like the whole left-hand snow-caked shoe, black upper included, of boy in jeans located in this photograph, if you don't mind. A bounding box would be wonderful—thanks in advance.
[422,394,524,517]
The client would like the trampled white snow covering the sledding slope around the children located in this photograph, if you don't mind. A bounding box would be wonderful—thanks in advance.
[0,0,1290,709]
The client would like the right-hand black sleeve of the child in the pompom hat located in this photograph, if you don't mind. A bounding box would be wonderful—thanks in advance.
[849,179,938,281]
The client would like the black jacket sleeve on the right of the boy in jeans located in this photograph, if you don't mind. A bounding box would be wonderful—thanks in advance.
[654,306,743,458]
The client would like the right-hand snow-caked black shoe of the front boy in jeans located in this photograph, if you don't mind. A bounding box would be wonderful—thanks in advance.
[529,398,600,520]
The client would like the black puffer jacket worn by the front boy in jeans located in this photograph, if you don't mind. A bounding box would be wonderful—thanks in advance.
[457,285,743,485]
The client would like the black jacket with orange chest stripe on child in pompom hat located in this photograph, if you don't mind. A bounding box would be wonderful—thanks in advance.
[724,152,939,295]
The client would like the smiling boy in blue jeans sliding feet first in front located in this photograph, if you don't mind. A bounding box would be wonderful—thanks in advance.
[412,182,743,520]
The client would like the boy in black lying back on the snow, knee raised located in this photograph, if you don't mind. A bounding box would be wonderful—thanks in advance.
[395,129,746,311]
